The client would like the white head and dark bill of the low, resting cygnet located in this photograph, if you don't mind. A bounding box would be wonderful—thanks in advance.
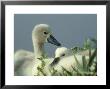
[50,47,72,66]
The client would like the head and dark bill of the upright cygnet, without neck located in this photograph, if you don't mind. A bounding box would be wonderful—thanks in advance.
[32,24,61,46]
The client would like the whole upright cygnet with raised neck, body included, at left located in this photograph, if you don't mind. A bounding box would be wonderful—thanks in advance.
[14,24,61,76]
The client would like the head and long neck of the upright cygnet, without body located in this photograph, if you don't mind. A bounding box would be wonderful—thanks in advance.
[32,24,61,58]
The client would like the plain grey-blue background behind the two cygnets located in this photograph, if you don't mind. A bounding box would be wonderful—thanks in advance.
[14,14,97,56]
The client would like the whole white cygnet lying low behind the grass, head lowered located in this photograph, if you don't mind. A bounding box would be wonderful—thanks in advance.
[33,47,96,76]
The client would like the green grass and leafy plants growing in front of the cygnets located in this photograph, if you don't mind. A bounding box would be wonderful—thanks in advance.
[34,39,97,76]
